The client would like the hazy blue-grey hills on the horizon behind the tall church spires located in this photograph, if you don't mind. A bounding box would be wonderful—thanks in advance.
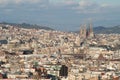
[75,25,120,34]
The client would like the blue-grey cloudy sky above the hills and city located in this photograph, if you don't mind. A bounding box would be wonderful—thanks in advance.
[0,0,120,31]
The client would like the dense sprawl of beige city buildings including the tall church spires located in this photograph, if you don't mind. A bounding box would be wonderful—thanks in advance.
[0,24,120,80]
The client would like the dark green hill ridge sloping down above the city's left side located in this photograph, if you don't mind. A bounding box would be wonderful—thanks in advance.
[0,22,54,30]
